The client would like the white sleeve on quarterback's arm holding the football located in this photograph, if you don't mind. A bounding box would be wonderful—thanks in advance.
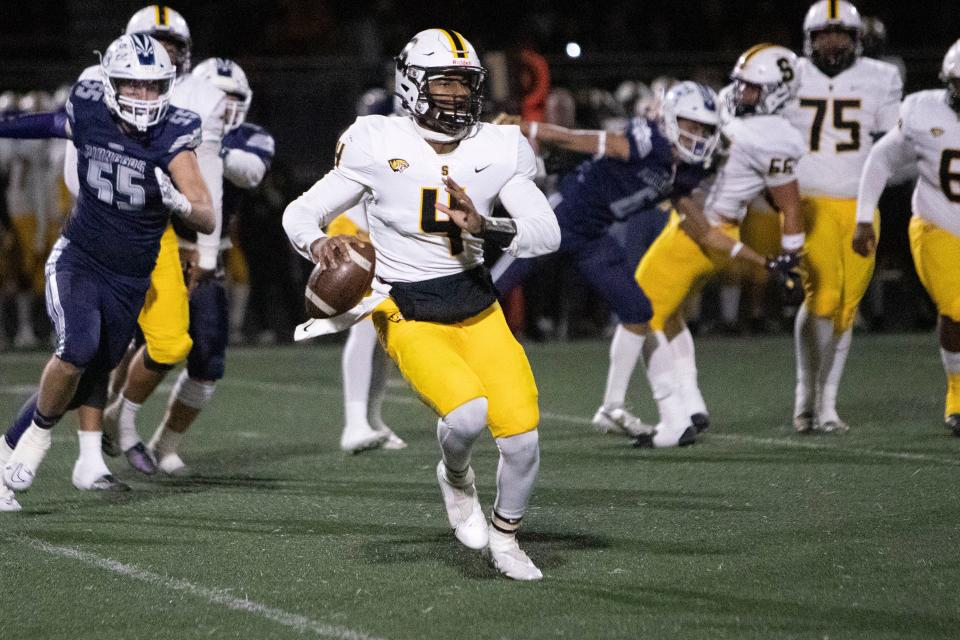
[283,169,366,262]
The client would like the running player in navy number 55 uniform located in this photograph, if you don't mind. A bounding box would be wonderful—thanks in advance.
[0,35,213,510]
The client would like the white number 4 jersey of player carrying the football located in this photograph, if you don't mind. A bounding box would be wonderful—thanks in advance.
[284,116,560,290]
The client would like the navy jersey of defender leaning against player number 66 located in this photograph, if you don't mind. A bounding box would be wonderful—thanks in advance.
[556,118,706,236]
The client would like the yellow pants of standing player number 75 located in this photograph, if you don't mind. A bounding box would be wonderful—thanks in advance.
[800,197,880,334]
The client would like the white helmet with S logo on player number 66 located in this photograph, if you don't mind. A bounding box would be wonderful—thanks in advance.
[727,43,799,115]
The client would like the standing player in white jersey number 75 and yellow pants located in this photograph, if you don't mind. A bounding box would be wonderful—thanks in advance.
[786,0,903,433]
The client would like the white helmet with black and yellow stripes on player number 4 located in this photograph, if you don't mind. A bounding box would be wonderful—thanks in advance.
[394,29,487,141]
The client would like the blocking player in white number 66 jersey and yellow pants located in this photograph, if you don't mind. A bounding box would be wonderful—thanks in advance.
[636,44,804,447]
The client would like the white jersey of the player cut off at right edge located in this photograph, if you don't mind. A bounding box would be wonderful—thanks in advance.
[857,89,960,237]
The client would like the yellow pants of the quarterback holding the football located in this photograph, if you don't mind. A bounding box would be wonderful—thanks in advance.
[372,298,540,438]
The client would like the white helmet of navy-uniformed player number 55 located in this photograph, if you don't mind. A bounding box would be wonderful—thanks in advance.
[100,33,177,131]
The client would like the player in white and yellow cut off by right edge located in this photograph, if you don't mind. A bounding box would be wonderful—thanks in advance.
[853,41,960,436]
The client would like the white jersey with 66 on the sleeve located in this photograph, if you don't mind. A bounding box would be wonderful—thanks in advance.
[704,115,805,224]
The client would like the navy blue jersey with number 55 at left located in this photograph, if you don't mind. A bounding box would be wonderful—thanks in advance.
[63,80,200,276]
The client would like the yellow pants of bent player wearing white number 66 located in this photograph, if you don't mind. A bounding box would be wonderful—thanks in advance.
[636,211,740,331]
